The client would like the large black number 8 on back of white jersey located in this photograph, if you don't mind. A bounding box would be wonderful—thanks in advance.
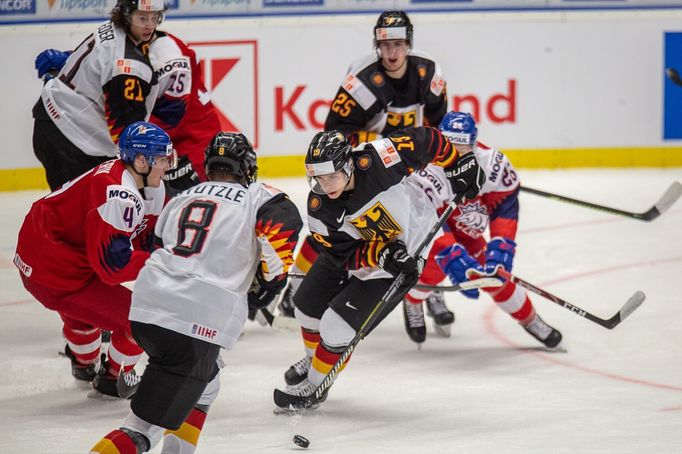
[173,200,216,257]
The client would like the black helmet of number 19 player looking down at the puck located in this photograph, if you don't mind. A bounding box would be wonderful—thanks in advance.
[305,130,353,194]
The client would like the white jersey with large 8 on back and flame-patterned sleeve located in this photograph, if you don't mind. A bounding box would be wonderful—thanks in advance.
[130,181,302,349]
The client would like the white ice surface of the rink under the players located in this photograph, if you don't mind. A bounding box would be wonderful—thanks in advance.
[0,169,682,454]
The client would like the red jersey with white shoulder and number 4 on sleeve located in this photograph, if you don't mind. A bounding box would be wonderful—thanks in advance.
[14,159,165,291]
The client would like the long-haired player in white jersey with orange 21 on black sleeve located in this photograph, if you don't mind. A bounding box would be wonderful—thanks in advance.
[33,0,165,190]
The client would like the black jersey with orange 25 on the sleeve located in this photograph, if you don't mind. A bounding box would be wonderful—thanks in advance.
[324,50,447,142]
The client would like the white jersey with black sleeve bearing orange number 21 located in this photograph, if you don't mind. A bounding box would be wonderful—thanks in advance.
[41,22,158,157]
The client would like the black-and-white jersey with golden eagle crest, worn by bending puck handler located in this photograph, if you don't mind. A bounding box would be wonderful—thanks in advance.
[308,127,459,279]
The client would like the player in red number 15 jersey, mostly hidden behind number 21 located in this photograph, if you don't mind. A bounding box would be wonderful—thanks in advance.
[36,0,220,196]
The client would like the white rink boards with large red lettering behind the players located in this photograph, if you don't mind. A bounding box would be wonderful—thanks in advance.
[0,10,682,169]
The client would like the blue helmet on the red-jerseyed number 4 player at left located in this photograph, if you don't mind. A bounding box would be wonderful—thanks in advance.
[118,121,177,169]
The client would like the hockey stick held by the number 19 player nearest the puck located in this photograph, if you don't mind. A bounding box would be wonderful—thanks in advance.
[273,204,455,410]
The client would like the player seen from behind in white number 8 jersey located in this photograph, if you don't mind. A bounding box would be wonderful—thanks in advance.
[90,132,303,454]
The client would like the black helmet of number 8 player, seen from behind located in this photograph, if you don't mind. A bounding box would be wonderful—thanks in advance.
[204,132,258,186]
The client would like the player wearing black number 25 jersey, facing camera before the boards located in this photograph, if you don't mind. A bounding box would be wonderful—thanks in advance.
[280,7,454,337]
